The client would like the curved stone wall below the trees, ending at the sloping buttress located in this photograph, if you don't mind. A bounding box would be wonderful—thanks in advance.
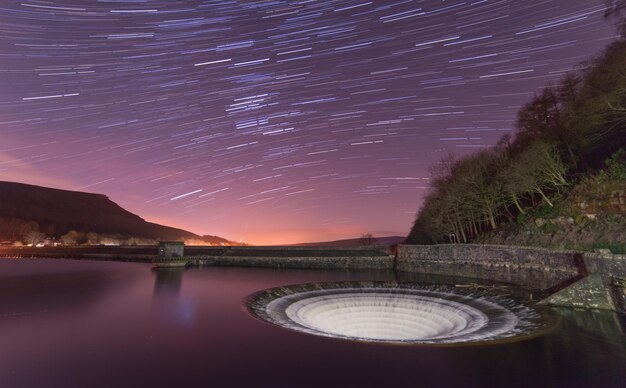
[396,244,585,290]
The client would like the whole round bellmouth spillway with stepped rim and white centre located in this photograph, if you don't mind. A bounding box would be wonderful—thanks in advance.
[244,282,559,346]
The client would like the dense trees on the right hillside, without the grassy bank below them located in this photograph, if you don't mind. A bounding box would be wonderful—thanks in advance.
[407,21,626,243]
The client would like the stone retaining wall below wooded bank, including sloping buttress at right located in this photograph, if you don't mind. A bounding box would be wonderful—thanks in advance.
[396,244,626,313]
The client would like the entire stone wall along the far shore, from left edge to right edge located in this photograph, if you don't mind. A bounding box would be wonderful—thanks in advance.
[0,242,626,313]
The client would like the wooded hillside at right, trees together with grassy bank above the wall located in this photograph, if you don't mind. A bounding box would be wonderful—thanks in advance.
[407,15,626,252]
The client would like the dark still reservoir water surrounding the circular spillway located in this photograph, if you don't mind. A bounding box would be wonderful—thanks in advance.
[0,259,626,387]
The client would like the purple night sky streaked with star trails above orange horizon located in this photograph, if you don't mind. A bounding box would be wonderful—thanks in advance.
[0,0,616,244]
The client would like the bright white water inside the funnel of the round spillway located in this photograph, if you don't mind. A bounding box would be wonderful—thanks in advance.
[286,292,500,340]
